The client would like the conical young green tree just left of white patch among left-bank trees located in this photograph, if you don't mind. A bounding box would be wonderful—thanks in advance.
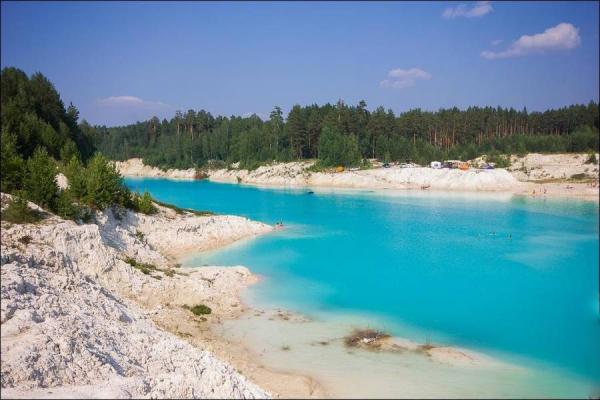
[23,147,58,209]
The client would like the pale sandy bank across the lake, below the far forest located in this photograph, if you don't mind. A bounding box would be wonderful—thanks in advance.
[116,153,599,201]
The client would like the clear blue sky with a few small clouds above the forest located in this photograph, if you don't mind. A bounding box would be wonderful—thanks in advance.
[1,1,599,125]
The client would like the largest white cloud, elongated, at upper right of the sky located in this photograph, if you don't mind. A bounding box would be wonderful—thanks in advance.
[481,22,581,60]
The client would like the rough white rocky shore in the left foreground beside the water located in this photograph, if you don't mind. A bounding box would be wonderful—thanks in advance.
[1,194,323,398]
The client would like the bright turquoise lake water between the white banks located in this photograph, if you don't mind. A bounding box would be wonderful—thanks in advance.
[126,179,600,386]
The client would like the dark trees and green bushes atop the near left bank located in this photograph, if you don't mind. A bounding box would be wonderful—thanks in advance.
[0,68,154,223]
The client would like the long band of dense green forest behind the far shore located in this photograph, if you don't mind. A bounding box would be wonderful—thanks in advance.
[93,101,599,168]
